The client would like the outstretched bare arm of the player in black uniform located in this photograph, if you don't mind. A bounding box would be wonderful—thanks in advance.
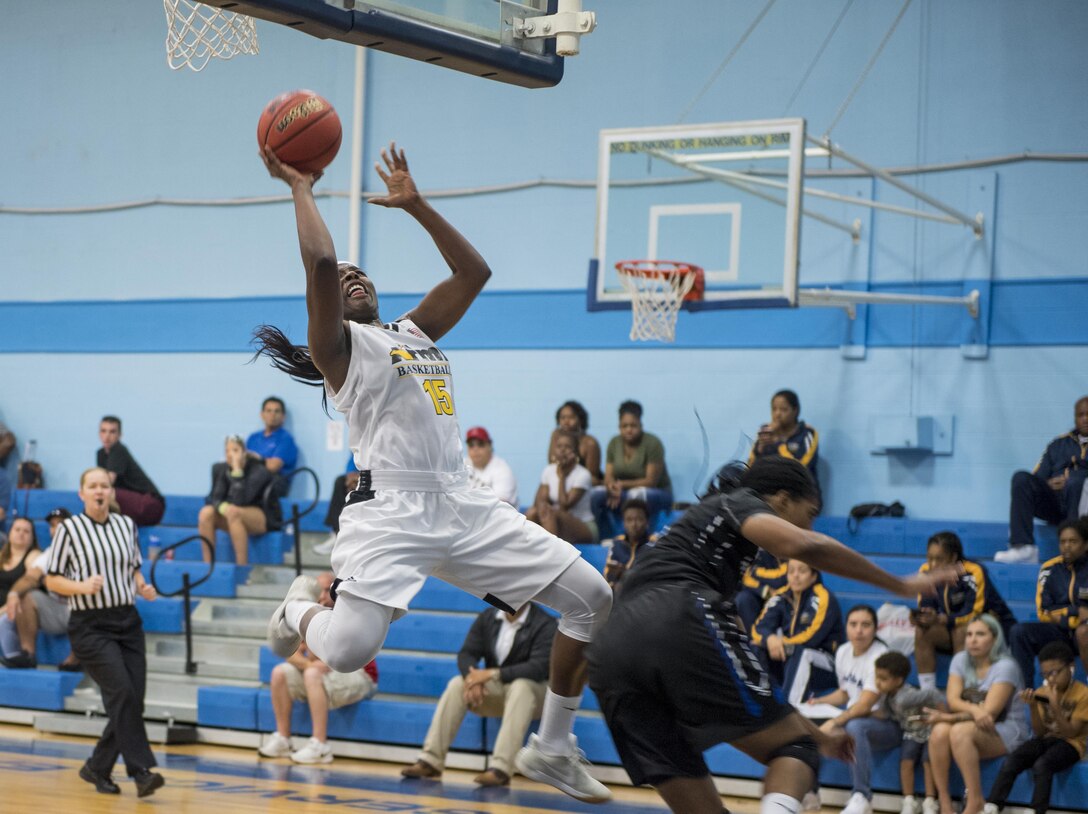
[741,514,959,599]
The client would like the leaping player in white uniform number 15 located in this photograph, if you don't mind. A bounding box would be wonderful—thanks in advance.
[257,145,611,802]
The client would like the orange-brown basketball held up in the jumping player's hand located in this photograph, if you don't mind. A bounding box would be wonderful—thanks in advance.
[257,90,343,172]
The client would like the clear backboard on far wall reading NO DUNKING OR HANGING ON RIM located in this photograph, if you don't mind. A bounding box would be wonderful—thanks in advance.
[588,119,805,310]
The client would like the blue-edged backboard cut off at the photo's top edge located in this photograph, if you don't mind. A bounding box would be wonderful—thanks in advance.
[198,0,564,87]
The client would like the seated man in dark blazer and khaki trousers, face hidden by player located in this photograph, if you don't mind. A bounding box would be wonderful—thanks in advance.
[400,600,557,786]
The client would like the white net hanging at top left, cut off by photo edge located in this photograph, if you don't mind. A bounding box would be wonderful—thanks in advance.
[162,0,259,71]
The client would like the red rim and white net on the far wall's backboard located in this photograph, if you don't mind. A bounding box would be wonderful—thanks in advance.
[616,260,703,342]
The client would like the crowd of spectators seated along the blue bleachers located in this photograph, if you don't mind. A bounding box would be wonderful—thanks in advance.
[0,390,1088,814]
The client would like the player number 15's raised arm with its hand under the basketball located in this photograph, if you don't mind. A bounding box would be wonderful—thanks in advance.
[261,148,350,391]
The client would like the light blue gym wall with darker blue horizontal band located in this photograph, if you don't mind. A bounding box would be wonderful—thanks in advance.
[0,0,1088,520]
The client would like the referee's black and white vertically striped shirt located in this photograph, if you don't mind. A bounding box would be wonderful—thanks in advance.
[46,511,143,611]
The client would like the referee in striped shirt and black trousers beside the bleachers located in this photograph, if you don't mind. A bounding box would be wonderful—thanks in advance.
[45,468,164,797]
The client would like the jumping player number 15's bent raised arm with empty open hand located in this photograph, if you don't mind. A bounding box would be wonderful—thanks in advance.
[370,143,491,341]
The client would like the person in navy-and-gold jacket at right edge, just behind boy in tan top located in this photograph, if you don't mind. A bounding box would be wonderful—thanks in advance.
[1009,518,1088,685]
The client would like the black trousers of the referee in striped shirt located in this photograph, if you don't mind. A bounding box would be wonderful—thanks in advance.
[69,605,156,776]
